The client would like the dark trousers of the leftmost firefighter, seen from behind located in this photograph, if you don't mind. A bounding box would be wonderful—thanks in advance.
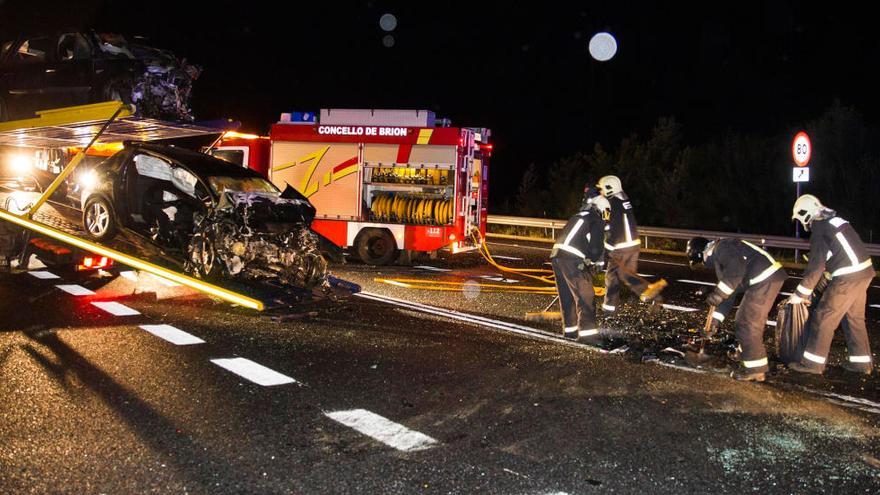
[550,254,598,337]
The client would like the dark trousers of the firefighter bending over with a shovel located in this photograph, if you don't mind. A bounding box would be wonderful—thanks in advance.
[735,276,788,373]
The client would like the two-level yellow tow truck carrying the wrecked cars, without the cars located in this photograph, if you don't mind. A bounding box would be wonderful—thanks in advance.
[0,102,359,310]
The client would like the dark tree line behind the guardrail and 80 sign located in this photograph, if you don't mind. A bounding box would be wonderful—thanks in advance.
[506,102,880,242]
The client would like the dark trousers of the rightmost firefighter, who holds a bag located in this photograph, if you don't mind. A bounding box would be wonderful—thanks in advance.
[801,277,873,370]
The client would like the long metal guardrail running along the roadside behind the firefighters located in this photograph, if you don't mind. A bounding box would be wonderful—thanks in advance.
[487,215,880,256]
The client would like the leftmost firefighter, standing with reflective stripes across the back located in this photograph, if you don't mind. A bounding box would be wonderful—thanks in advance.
[550,187,608,345]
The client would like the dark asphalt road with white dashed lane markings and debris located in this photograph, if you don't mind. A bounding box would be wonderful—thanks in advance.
[0,245,880,494]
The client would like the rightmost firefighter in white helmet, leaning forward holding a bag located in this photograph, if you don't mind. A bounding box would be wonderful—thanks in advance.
[788,194,875,374]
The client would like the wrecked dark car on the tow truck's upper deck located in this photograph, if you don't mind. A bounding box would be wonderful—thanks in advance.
[0,30,201,122]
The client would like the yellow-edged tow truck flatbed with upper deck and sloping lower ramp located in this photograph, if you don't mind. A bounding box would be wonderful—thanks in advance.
[0,102,359,310]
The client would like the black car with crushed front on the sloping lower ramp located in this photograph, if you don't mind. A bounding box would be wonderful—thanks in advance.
[77,143,328,289]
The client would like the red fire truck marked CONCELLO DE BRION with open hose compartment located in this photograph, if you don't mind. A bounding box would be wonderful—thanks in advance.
[218,109,492,265]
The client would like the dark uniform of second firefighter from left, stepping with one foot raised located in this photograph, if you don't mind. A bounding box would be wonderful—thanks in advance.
[602,192,649,313]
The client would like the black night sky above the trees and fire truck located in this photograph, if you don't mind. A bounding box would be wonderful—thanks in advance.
[0,0,880,203]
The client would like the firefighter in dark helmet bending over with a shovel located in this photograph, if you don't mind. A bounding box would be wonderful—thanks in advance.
[687,237,788,382]
